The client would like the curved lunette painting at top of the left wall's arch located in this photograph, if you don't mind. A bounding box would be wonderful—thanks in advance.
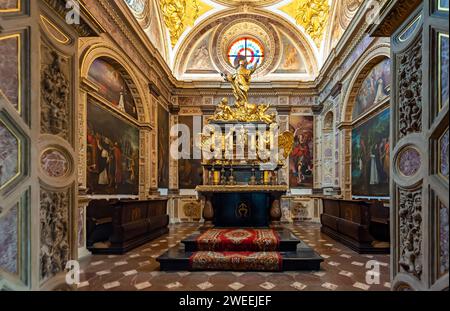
[88,58,138,119]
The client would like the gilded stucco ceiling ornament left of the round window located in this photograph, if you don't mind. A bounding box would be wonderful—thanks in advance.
[159,0,212,47]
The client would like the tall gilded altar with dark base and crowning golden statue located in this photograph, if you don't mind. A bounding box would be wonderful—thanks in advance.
[196,60,294,227]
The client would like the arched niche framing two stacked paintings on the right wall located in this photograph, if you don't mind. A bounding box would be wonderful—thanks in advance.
[340,44,390,199]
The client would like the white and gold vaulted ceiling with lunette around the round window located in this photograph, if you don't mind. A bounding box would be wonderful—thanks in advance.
[123,0,363,81]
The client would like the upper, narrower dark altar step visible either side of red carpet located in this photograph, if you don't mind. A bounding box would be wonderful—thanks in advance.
[181,228,301,252]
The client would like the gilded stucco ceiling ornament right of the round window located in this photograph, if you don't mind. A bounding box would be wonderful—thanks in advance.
[281,0,330,47]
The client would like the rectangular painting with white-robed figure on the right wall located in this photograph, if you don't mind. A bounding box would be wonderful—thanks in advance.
[352,109,390,197]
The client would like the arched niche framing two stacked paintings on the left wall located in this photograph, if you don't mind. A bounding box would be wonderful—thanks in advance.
[78,39,154,197]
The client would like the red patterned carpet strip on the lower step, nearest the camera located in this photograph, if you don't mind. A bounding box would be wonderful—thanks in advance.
[189,252,283,272]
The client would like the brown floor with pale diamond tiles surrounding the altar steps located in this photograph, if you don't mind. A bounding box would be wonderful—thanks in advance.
[78,223,391,291]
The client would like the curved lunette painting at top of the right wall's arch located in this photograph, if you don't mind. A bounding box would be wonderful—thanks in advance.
[353,59,391,120]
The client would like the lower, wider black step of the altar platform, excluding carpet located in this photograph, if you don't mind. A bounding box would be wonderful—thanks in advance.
[157,241,323,272]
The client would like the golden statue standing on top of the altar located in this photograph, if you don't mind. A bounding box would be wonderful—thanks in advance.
[222,59,259,107]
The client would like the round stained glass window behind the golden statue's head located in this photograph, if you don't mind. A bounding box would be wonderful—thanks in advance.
[228,38,264,67]
